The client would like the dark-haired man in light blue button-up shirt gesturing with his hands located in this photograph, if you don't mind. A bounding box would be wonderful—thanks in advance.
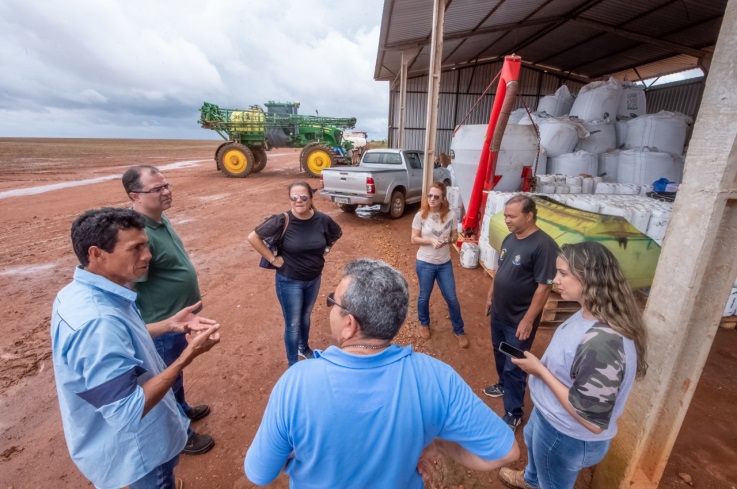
[51,208,220,489]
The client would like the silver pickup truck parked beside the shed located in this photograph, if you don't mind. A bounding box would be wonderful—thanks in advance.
[320,149,450,219]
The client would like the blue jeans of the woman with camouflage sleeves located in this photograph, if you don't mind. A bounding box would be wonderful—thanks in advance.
[525,409,611,489]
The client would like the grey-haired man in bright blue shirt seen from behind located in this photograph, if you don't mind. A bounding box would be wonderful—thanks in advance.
[245,259,519,488]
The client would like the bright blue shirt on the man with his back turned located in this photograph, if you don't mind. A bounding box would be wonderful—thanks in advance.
[245,345,514,489]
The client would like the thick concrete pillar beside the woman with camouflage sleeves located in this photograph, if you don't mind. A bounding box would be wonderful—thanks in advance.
[591,0,737,489]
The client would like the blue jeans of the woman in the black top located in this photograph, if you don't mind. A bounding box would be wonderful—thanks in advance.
[276,273,321,367]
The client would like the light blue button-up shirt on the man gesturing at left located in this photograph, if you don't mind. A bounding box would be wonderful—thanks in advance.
[51,268,189,489]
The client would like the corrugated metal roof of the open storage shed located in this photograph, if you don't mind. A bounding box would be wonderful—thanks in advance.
[374,0,727,81]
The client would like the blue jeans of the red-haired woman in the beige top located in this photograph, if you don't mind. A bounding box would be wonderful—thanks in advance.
[415,260,464,335]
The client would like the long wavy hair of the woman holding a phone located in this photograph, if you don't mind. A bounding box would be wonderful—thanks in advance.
[559,241,647,377]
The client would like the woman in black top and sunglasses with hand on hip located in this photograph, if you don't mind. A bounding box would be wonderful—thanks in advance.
[248,182,343,367]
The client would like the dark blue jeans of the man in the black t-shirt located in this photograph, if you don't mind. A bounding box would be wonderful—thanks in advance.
[491,312,539,417]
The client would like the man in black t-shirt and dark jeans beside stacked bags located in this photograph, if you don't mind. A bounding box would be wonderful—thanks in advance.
[484,194,558,431]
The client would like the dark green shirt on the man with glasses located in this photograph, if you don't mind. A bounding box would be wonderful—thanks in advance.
[136,214,201,323]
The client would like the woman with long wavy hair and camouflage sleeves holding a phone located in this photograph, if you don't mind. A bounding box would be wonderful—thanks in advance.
[499,242,647,489]
